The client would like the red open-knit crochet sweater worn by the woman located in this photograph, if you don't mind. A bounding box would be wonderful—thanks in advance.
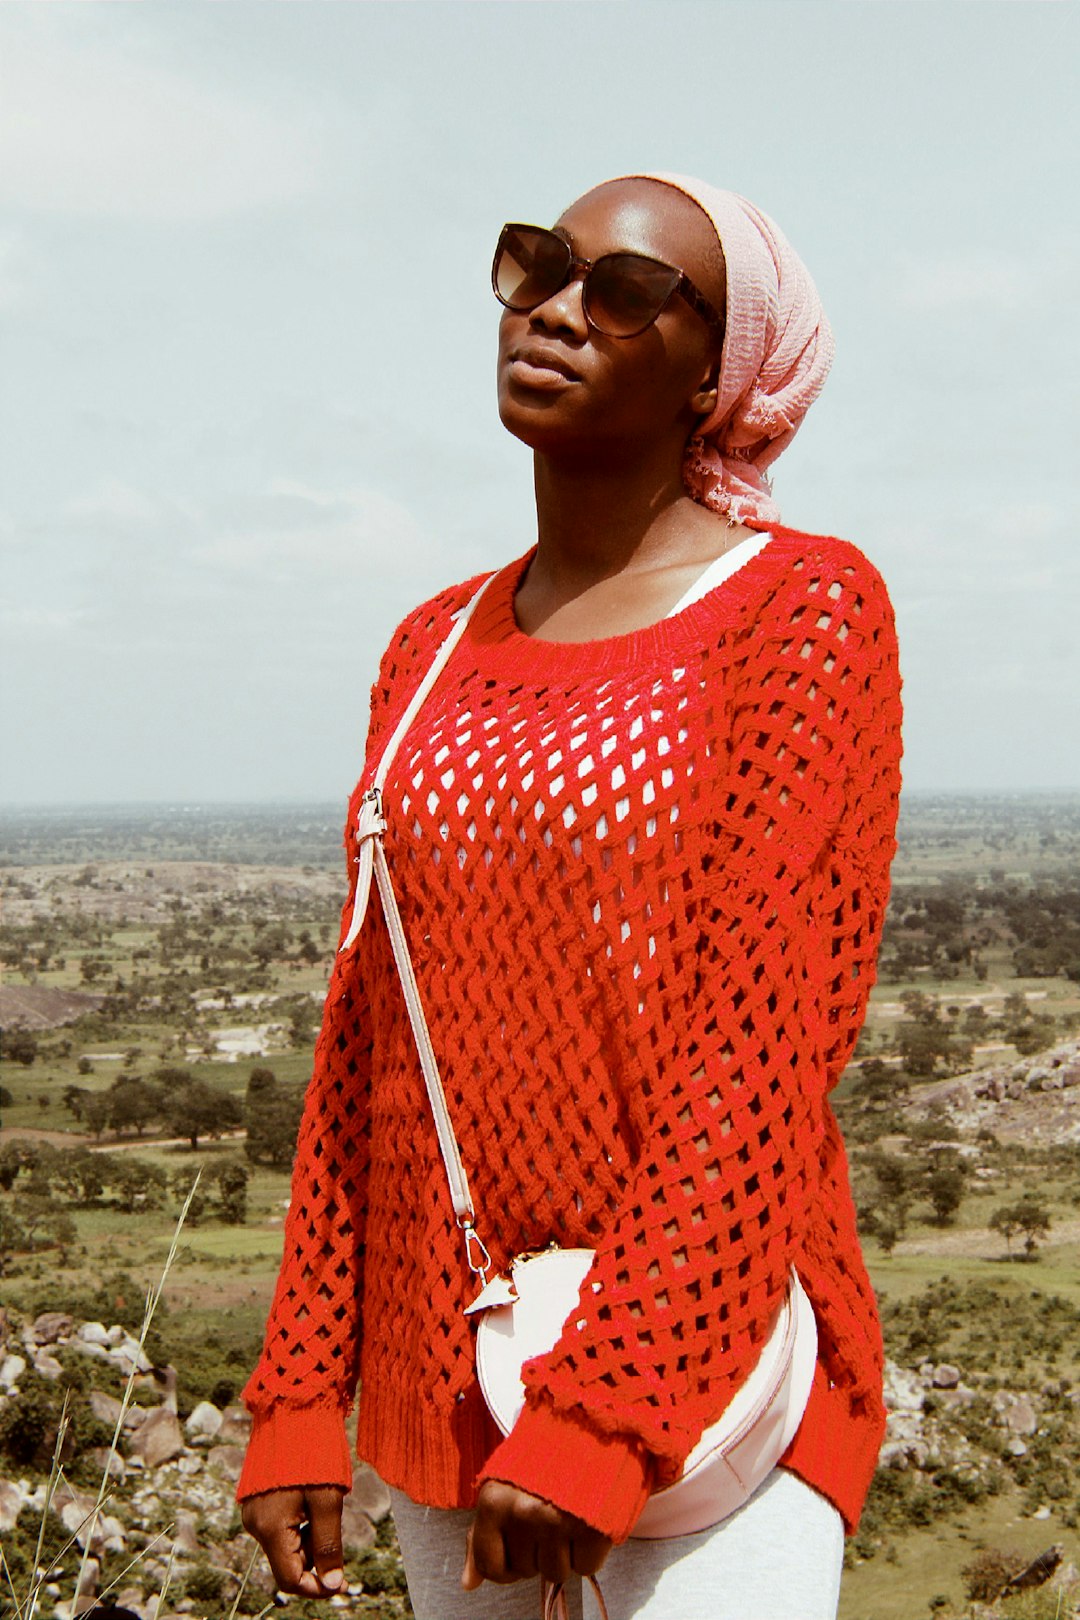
[240,528,900,1541]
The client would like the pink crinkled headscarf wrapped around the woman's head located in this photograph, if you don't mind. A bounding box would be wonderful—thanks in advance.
[628,175,832,523]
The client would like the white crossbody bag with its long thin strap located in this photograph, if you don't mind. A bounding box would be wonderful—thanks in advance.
[342,580,818,1539]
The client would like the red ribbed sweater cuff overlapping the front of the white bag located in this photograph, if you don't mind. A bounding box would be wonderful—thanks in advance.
[478,1405,653,1542]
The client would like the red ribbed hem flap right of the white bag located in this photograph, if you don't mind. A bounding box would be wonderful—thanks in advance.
[780,1362,886,1536]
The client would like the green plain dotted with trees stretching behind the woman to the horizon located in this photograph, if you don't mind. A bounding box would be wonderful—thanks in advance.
[0,797,1080,1620]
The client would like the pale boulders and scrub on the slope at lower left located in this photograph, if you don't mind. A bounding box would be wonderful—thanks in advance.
[0,1311,410,1620]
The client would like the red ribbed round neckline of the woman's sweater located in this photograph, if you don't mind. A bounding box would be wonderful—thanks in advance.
[466,528,797,679]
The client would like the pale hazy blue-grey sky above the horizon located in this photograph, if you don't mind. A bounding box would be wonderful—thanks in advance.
[0,0,1080,805]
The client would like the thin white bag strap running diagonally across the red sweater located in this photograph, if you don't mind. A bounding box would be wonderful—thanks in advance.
[342,573,495,1283]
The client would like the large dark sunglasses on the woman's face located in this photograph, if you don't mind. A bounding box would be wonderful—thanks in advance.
[491,225,724,342]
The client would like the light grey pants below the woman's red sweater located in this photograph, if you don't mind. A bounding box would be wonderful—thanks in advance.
[390,1468,844,1620]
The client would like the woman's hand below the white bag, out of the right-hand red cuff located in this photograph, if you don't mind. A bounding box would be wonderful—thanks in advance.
[461,1479,612,1592]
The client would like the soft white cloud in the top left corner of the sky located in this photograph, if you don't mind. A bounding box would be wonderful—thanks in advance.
[0,8,319,220]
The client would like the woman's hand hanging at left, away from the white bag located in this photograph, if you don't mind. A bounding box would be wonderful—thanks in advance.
[240,1486,346,1597]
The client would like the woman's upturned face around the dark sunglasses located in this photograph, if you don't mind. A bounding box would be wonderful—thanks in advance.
[499,180,725,457]
